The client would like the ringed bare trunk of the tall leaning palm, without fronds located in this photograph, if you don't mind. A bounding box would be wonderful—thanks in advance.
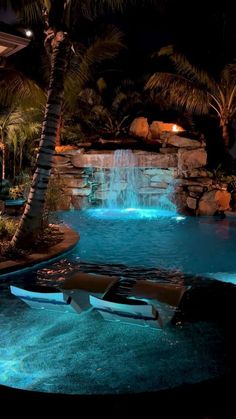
[11,32,70,248]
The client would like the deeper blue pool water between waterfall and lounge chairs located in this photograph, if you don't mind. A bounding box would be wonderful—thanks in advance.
[62,208,236,283]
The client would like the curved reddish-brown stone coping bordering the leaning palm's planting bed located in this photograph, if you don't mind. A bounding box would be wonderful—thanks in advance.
[0,224,80,275]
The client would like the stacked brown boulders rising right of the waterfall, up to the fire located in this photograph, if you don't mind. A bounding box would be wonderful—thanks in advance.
[129,118,231,215]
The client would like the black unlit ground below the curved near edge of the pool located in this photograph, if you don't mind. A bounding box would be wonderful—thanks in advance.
[0,371,236,419]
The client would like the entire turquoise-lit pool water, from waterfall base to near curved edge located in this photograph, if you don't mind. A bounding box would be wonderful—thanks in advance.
[0,209,236,394]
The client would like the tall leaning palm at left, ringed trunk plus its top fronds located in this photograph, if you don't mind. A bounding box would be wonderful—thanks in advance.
[0,0,164,247]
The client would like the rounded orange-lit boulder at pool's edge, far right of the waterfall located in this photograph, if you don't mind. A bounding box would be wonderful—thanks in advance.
[197,189,231,215]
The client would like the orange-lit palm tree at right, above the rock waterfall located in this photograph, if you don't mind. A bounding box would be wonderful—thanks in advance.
[146,48,236,151]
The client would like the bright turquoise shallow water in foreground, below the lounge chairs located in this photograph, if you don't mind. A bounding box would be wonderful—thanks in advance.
[0,295,229,394]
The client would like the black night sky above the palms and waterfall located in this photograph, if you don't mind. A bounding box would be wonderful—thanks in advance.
[0,0,236,76]
